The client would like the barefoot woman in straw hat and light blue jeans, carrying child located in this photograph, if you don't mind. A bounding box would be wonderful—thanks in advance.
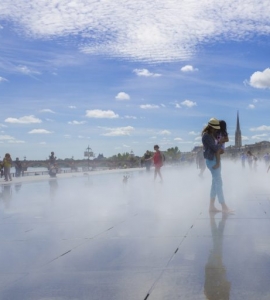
[202,118,231,212]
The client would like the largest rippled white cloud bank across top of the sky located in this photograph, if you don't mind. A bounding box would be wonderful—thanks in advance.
[1,0,270,62]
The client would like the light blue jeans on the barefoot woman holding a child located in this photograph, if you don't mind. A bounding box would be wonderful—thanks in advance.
[205,158,225,204]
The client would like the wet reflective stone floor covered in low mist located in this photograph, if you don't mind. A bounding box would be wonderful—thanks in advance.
[0,162,270,300]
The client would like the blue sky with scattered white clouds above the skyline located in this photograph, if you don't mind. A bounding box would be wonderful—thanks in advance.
[0,0,270,160]
